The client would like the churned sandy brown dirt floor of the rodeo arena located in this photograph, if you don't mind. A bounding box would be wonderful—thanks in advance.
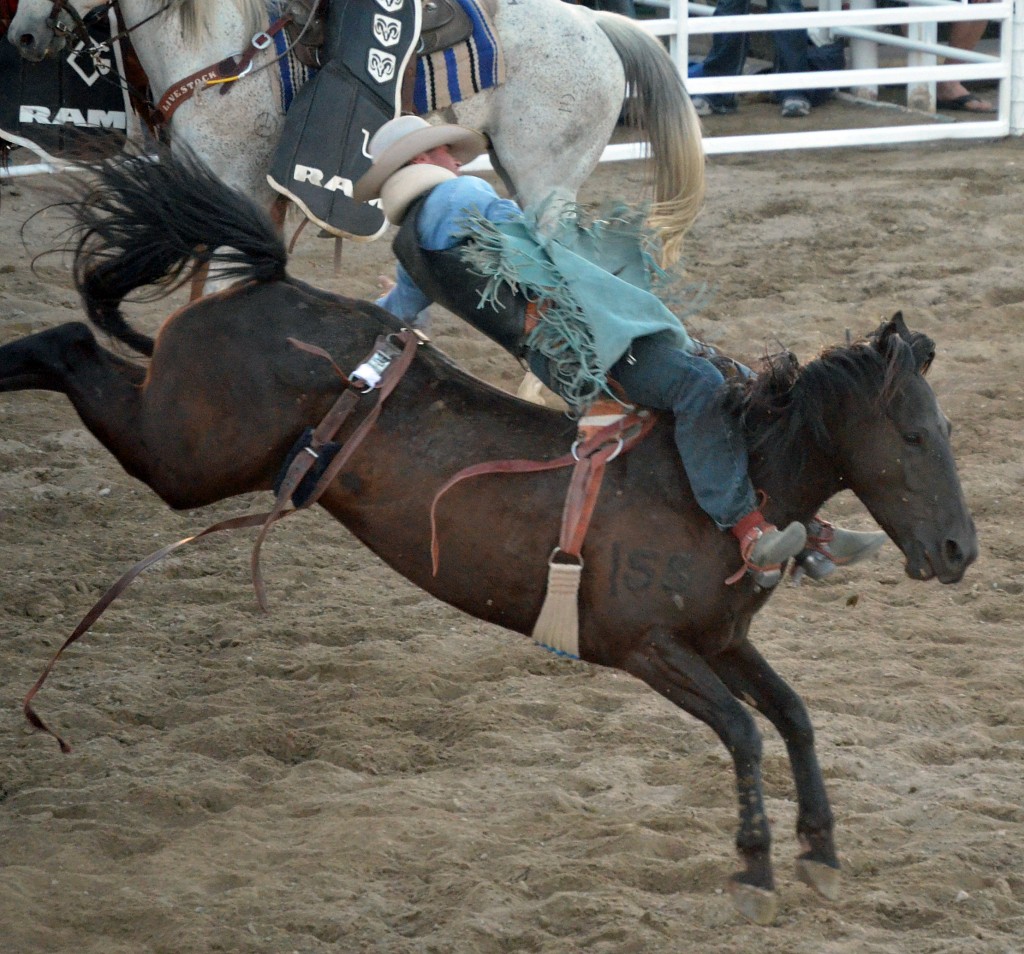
[0,98,1024,954]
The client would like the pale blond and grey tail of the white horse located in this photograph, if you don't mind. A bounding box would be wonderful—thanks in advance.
[595,13,705,264]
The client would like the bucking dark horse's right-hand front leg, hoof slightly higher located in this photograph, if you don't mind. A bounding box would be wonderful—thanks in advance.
[710,641,840,901]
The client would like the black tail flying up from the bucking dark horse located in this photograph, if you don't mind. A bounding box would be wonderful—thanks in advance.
[71,149,288,354]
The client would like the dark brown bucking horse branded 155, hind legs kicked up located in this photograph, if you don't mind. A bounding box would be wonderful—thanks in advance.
[0,150,977,923]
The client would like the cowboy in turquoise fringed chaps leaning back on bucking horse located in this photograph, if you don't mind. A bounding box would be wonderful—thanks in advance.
[354,116,886,589]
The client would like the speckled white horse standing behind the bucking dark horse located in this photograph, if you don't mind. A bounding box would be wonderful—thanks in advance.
[7,0,703,261]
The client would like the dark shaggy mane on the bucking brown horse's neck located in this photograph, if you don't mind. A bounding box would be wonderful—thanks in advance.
[726,314,935,479]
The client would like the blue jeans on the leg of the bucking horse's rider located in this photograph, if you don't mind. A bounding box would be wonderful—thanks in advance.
[529,335,758,530]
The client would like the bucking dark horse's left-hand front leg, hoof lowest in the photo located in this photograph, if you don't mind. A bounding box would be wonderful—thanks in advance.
[617,630,777,924]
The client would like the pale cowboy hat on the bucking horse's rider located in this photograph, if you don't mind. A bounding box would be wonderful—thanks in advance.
[352,116,487,202]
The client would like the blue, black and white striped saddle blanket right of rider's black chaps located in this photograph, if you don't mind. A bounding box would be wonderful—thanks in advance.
[413,0,505,116]
